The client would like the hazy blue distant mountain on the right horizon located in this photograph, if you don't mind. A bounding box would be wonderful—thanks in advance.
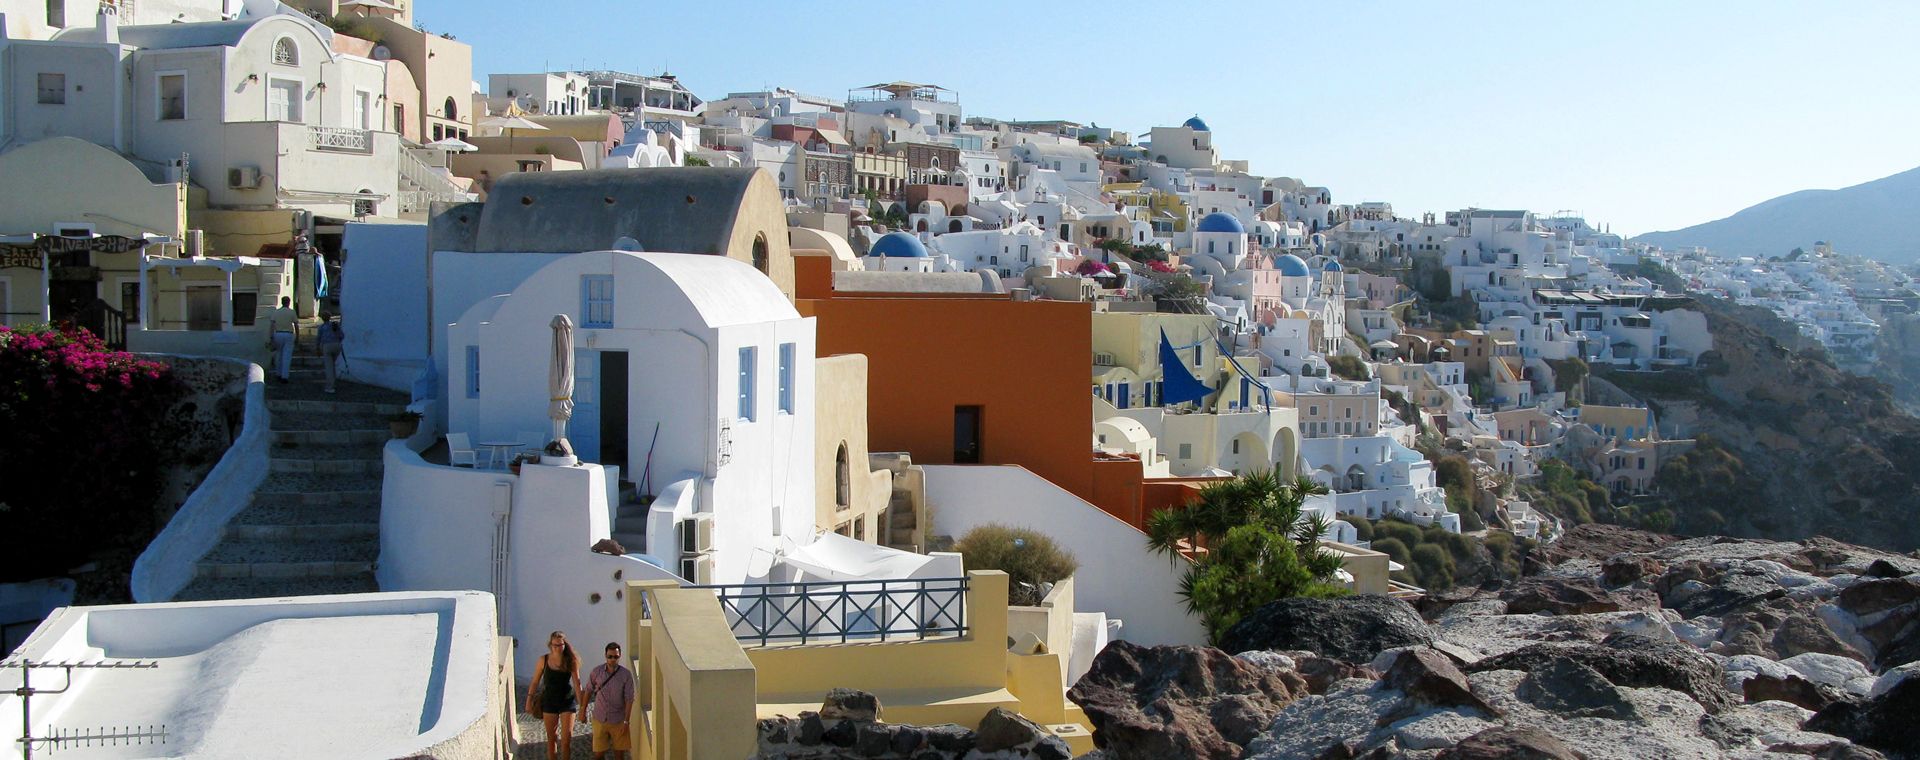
[1634,169,1920,263]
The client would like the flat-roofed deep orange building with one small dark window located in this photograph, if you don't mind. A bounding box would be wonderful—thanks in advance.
[795,255,1094,501]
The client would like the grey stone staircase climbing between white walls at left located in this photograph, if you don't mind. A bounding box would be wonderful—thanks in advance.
[177,355,407,601]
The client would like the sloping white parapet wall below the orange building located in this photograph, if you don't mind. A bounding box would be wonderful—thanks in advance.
[924,464,1206,645]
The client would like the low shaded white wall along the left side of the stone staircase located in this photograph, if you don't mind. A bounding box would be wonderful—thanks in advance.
[132,363,273,603]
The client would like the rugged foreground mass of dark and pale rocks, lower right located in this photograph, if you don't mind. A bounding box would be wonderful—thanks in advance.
[1069,526,1920,760]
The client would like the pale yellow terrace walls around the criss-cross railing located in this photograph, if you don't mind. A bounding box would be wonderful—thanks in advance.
[626,570,1092,760]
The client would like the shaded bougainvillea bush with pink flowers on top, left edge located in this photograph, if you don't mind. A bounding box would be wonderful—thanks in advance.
[0,326,180,580]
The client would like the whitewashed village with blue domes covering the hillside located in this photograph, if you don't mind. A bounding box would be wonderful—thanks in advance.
[0,0,1920,758]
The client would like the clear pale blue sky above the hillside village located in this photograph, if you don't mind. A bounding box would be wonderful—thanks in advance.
[432,0,1920,234]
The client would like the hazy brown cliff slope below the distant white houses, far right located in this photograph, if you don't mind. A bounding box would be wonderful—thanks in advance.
[1601,299,1920,551]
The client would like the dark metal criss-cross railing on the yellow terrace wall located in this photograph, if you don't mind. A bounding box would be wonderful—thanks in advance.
[697,578,968,647]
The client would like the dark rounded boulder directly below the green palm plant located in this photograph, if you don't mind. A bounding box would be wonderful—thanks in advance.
[1221,595,1432,664]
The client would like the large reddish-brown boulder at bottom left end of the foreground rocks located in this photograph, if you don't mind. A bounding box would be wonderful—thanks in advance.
[1068,641,1308,758]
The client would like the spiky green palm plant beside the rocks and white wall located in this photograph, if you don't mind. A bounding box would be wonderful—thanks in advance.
[1146,470,1346,643]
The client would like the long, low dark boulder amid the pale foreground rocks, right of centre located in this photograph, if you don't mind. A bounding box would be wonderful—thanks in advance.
[1467,633,1734,712]
